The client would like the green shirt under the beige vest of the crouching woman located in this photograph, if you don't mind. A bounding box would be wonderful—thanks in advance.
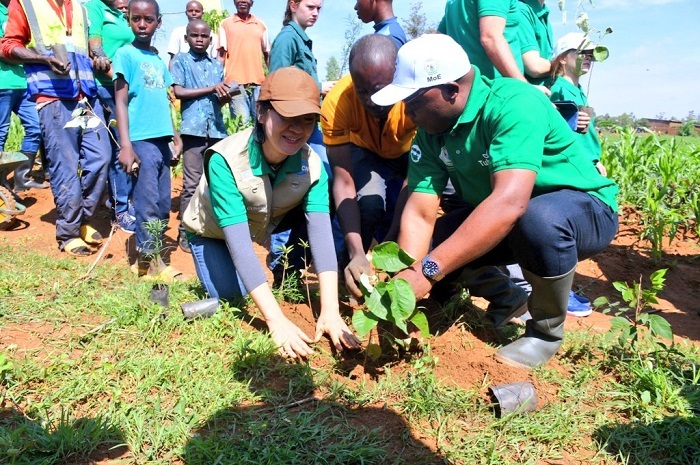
[206,137,330,229]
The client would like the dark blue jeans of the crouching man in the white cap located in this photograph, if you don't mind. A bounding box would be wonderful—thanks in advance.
[433,189,618,277]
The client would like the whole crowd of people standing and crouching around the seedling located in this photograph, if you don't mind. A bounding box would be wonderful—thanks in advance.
[0,0,618,368]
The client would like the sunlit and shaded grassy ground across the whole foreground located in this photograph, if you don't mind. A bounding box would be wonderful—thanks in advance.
[0,238,700,464]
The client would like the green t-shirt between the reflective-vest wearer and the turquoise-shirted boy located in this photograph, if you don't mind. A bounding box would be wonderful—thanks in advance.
[85,0,134,87]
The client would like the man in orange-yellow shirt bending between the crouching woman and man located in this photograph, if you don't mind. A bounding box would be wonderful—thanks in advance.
[321,34,527,326]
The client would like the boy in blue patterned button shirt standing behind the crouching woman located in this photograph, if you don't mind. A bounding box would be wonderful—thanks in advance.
[170,19,231,253]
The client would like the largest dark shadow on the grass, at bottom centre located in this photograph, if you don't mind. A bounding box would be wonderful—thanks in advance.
[182,354,444,465]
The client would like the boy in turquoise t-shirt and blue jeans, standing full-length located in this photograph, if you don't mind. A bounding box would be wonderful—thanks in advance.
[112,0,182,277]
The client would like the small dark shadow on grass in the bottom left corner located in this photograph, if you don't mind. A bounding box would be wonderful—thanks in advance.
[0,409,129,465]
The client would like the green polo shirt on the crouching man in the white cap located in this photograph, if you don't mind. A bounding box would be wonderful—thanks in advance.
[408,70,618,211]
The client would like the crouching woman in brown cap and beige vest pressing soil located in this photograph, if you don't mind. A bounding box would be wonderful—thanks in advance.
[183,67,360,358]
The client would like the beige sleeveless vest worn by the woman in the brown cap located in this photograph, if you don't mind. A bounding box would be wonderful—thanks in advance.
[182,128,323,244]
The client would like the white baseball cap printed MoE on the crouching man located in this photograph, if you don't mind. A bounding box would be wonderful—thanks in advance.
[372,34,472,106]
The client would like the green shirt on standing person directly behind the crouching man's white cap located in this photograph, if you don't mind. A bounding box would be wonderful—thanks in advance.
[438,0,523,78]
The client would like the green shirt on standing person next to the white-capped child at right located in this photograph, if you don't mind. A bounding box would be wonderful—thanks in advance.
[518,0,554,85]
